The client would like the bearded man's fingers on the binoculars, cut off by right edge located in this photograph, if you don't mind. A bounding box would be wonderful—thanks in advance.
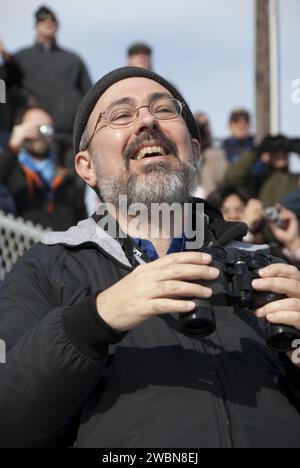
[253,264,300,367]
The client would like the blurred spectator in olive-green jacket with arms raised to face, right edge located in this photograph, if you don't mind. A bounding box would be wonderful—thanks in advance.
[226,135,300,207]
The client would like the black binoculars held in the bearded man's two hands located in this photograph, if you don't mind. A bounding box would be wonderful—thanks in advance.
[179,246,300,352]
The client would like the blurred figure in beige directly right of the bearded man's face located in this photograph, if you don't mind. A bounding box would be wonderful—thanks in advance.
[194,112,228,198]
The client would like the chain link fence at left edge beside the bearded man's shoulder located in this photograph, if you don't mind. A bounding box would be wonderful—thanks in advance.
[0,211,46,281]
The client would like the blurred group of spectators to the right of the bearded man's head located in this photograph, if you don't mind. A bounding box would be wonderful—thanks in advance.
[195,109,300,266]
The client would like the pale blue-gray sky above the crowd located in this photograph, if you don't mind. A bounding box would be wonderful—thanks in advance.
[0,0,300,136]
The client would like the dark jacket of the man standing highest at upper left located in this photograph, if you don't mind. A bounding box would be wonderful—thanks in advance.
[5,43,92,133]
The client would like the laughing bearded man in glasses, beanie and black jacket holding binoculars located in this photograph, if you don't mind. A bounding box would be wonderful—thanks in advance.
[0,67,300,448]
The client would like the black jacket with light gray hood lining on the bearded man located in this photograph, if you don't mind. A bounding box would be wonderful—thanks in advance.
[0,199,300,448]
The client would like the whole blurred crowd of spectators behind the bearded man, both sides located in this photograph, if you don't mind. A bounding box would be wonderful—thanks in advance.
[0,6,300,260]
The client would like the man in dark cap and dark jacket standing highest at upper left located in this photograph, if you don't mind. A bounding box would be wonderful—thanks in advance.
[0,6,91,165]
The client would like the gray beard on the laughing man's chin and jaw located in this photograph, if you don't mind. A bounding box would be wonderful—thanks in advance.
[95,161,197,209]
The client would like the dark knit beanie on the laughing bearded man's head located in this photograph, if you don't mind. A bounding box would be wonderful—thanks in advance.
[73,67,200,154]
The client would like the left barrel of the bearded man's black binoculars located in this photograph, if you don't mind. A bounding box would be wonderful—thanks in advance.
[179,247,226,338]
